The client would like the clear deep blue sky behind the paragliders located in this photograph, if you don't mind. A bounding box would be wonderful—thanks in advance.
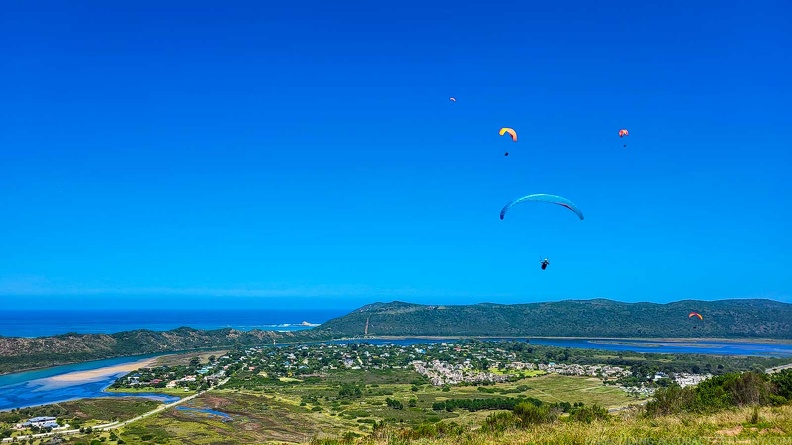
[0,0,792,307]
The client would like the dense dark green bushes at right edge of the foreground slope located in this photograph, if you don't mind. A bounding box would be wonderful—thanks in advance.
[646,370,792,416]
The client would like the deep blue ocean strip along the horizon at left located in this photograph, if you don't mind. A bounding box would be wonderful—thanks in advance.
[0,309,351,337]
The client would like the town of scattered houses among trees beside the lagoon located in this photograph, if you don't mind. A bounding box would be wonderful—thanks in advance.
[111,340,712,396]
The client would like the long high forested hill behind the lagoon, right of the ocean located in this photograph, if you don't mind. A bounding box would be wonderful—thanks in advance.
[315,299,792,339]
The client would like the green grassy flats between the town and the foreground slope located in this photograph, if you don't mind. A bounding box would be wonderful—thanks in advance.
[106,370,635,444]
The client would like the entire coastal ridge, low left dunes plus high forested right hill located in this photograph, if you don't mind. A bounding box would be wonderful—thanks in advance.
[0,299,792,373]
